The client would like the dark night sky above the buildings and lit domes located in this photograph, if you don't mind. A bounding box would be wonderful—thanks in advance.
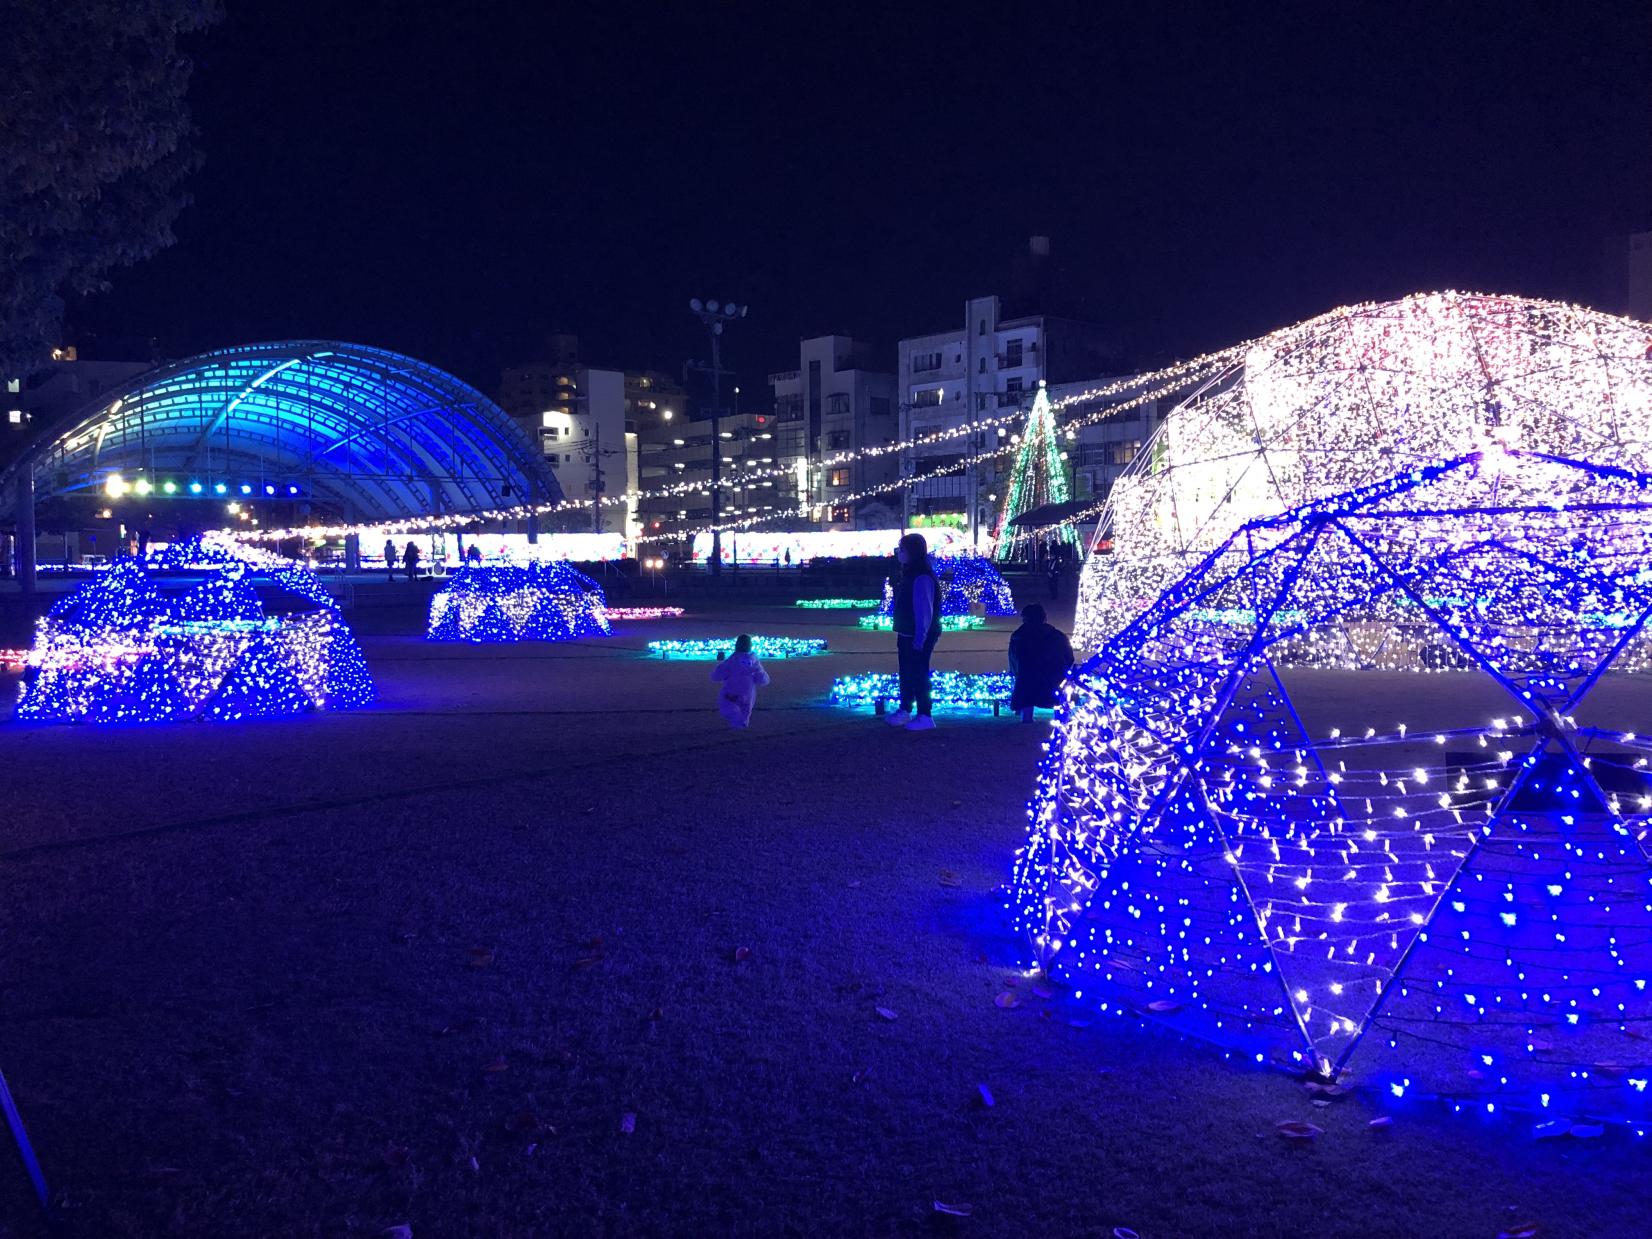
[71,0,1652,392]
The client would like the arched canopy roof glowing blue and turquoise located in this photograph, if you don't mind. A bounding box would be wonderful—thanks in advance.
[35,340,562,520]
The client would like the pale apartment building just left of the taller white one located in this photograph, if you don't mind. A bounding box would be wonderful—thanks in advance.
[768,335,900,530]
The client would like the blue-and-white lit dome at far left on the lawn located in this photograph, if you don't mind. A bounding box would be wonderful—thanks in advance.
[17,539,373,722]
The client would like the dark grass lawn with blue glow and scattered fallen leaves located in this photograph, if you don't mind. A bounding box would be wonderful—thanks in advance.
[0,606,1652,1239]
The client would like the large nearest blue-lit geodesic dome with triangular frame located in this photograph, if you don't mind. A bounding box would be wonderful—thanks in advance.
[1009,451,1652,1123]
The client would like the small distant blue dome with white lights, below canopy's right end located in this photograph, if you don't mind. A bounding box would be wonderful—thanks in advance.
[426,560,611,643]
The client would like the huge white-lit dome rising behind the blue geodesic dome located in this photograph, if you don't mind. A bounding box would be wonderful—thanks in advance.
[1074,292,1652,649]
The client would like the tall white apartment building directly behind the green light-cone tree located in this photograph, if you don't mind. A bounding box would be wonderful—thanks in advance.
[897,297,1112,545]
